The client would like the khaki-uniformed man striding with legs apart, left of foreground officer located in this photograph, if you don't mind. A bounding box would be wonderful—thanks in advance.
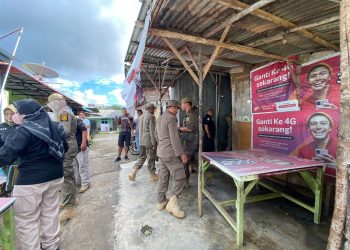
[129,103,159,181]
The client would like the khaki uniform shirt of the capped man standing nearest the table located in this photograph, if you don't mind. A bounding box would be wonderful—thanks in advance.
[156,111,184,159]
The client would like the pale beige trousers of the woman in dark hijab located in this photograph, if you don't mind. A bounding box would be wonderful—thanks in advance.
[13,178,63,250]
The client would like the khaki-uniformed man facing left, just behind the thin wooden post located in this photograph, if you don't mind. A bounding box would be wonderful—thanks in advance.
[179,97,199,188]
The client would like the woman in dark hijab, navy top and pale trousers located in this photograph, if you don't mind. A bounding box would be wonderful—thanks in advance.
[0,99,68,250]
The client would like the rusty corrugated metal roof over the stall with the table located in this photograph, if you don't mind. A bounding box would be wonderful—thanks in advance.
[125,0,339,86]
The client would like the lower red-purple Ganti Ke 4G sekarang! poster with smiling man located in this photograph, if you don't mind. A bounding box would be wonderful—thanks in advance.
[253,109,339,175]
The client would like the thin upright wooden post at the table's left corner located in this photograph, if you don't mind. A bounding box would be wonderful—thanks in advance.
[198,46,203,217]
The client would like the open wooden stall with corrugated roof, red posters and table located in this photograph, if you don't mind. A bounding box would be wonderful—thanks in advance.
[125,0,348,246]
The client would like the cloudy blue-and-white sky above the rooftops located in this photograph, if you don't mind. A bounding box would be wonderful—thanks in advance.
[0,0,141,105]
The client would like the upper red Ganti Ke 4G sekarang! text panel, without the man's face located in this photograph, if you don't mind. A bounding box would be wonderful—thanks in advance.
[250,62,298,113]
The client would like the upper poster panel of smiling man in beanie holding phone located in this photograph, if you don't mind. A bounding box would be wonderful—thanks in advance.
[300,54,340,110]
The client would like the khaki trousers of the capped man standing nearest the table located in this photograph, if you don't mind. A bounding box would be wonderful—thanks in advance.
[158,157,186,203]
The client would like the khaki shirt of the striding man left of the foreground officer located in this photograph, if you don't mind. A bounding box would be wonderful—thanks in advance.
[138,110,157,148]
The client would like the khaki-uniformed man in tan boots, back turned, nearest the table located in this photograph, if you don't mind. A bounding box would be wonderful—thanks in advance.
[156,100,188,219]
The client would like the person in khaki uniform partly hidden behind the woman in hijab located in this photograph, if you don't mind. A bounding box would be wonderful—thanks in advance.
[47,93,78,222]
